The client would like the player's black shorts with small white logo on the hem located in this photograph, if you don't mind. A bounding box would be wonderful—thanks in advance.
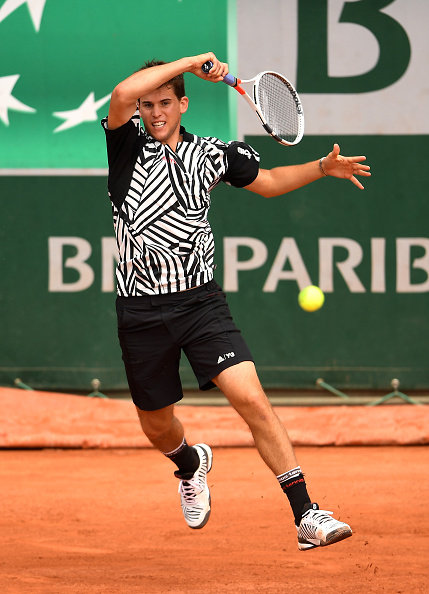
[116,280,253,410]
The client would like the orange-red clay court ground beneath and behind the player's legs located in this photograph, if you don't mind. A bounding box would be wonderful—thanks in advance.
[0,389,429,594]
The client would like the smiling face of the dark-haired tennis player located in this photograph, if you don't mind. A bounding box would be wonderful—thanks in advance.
[139,86,188,150]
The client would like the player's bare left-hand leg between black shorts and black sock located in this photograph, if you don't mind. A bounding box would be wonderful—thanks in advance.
[136,404,184,453]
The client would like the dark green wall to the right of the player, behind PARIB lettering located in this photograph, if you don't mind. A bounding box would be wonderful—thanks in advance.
[212,136,429,389]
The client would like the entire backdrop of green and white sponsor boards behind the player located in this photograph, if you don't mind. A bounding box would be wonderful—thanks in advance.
[0,0,429,390]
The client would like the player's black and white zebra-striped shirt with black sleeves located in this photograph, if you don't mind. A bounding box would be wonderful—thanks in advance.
[102,111,259,297]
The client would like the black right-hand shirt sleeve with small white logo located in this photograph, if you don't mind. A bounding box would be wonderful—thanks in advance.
[222,142,259,188]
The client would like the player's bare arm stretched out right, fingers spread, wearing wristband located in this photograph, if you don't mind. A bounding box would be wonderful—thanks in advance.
[246,144,371,198]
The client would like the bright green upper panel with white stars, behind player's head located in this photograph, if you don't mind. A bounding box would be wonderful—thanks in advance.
[0,0,234,169]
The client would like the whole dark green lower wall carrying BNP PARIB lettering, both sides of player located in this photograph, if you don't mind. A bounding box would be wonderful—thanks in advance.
[0,132,429,389]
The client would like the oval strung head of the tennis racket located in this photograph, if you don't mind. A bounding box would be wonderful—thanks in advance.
[256,72,302,142]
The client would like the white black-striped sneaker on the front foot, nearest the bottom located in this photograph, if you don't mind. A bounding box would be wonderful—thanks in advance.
[297,503,353,551]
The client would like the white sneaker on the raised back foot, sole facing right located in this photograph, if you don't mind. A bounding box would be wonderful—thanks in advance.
[175,443,213,528]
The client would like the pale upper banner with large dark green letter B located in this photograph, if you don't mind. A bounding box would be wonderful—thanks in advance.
[237,0,429,138]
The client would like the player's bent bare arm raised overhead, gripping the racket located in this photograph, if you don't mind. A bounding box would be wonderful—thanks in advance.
[108,52,228,130]
